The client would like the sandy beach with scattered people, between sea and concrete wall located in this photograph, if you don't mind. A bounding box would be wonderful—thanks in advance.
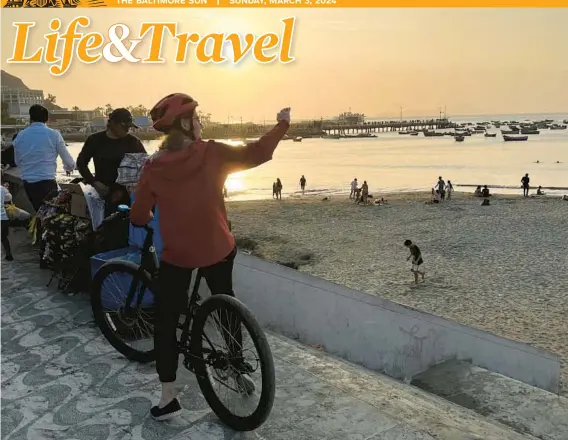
[227,193,568,395]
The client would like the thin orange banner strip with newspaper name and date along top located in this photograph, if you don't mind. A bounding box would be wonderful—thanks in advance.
[2,0,568,8]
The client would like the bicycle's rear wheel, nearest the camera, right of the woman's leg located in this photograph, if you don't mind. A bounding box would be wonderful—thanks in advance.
[191,295,276,431]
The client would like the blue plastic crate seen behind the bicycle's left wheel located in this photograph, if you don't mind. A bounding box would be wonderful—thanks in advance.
[91,246,154,310]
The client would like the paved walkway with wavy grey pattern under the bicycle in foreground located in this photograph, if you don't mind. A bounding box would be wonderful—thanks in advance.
[1,232,532,440]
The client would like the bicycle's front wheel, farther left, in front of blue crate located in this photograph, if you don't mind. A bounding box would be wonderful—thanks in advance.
[91,261,155,363]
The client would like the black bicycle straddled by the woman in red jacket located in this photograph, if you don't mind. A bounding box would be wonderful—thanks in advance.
[91,205,275,431]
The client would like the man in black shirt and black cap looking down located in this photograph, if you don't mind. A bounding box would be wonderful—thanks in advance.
[77,108,146,198]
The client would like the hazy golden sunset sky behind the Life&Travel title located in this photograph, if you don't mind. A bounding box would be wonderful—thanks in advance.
[1,8,568,121]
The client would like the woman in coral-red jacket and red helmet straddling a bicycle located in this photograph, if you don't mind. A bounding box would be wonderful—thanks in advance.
[130,93,290,420]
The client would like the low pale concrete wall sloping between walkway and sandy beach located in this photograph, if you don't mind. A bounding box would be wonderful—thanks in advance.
[213,253,560,392]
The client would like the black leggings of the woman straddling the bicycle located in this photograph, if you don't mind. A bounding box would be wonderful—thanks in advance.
[154,248,242,382]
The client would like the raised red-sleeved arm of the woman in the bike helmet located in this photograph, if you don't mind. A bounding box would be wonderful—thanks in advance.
[217,108,290,173]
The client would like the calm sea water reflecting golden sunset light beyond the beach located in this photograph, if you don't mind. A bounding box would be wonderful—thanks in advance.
[60,115,568,200]
